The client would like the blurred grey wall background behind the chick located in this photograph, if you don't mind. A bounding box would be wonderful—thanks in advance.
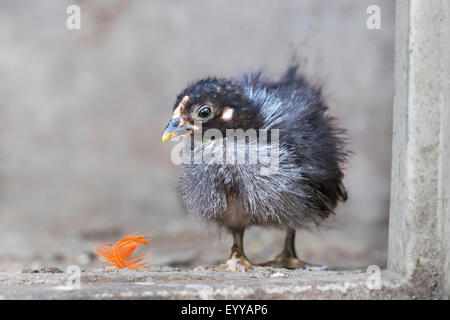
[0,0,395,271]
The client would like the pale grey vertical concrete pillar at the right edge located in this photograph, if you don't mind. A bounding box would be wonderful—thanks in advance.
[388,0,450,297]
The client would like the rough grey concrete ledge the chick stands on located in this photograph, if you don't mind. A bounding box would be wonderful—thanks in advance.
[0,267,430,299]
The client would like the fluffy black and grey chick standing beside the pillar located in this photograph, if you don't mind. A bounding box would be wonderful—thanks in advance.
[162,66,349,270]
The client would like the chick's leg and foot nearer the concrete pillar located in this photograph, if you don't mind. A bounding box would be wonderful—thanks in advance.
[262,228,328,270]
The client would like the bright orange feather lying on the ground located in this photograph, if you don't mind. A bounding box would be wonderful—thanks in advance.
[94,233,150,270]
